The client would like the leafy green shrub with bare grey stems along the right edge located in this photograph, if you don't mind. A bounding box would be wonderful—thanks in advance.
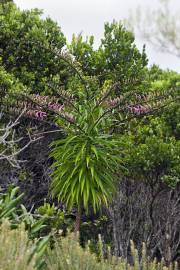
[109,69,180,264]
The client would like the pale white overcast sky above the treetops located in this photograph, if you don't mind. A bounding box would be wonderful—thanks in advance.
[14,0,180,72]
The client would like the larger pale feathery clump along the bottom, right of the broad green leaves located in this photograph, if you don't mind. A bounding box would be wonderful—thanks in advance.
[46,235,178,270]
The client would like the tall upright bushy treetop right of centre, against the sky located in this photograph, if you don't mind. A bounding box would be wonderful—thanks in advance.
[100,22,147,86]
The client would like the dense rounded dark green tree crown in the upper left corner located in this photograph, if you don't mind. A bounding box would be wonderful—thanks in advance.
[0,4,65,93]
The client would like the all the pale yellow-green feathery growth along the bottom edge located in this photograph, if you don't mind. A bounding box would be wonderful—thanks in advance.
[0,220,178,270]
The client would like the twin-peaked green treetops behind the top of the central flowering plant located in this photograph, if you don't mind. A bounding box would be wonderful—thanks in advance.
[69,21,147,90]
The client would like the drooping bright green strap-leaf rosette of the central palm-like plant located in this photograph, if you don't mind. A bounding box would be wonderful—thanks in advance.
[51,117,124,214]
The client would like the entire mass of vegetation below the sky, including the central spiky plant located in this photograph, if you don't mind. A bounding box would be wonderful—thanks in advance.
[0,1,180,270]
